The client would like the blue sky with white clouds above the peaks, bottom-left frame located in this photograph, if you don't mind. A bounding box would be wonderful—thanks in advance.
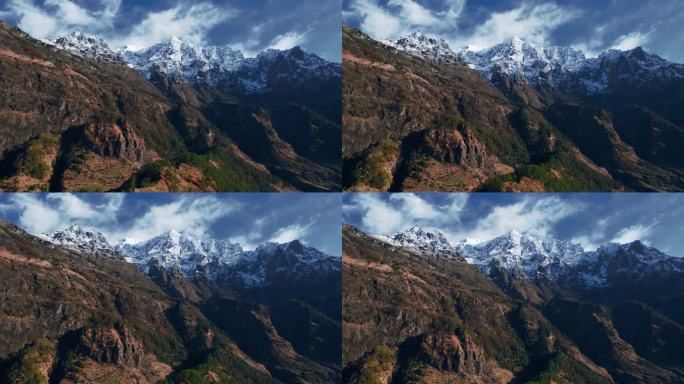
[0,193,342,256]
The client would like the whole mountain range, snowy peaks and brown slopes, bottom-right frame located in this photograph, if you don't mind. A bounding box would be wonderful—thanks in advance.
[342,225,684,383]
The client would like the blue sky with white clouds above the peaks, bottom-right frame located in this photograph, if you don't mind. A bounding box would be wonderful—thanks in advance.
[343,193,684,257]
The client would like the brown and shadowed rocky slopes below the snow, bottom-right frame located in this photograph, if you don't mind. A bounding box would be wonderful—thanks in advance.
[342,226,684,383]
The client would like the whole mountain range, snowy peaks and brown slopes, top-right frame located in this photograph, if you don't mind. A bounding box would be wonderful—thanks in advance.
[342,27,684,191]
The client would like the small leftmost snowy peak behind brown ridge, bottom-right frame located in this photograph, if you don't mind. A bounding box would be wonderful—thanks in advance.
[375,226,463,261]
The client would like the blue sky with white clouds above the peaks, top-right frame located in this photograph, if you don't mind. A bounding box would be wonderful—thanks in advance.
[342,0,684,63]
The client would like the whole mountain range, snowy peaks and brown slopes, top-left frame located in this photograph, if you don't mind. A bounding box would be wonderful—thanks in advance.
[0,23,341,191]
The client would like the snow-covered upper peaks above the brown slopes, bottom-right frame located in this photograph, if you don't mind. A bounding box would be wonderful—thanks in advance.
[375,227,684,287]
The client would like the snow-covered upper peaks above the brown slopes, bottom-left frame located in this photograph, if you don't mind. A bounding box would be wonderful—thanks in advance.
[41,225,341,287]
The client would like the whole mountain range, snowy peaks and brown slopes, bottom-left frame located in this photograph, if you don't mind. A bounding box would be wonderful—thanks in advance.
[0,222,341,383]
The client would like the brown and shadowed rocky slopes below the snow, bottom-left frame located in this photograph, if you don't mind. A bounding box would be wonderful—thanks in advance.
[0,222,340,384]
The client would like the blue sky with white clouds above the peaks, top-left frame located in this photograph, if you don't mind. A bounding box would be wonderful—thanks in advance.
[0,0,342,61]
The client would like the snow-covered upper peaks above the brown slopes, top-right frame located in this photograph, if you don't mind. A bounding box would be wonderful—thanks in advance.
[386,32,684,94]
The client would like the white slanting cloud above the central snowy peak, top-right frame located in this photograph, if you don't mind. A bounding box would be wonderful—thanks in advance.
[452,2,580,50]
